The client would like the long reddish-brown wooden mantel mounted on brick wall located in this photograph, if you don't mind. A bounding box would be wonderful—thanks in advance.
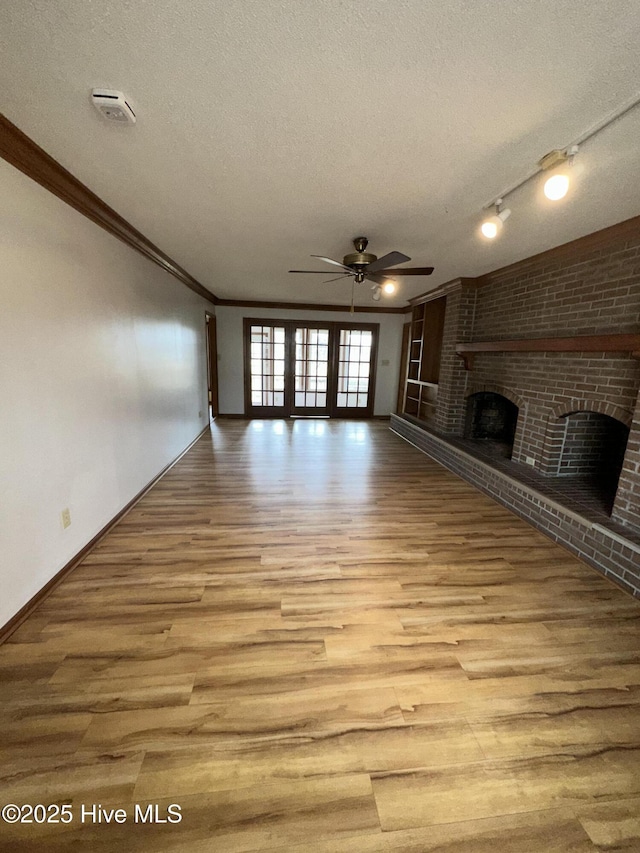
[456,335,640,370]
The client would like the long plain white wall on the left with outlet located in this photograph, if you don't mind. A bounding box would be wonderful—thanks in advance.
[0,160,213,625]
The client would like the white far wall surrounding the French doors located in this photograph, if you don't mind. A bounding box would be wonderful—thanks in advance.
[216,305,405,415]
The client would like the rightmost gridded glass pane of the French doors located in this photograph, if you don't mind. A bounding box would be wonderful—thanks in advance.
[336,329,373,417]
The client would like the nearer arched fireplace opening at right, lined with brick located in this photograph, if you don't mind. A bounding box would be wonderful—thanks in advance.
[558,411,629,513]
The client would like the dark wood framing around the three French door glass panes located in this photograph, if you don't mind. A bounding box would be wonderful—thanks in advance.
[242,317,380,418]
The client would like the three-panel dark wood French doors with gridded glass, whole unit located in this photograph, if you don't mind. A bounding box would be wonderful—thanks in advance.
[244,319,379,418]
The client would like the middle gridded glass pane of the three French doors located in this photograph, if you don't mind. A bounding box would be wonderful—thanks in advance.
[291,326,329,415]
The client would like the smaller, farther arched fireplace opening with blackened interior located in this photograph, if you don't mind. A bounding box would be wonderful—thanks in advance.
[464,391,518,459]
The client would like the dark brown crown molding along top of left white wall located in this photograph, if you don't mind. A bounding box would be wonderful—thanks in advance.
[0,114,218,305]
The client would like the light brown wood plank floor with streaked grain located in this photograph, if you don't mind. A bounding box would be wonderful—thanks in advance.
[0,420,640,853]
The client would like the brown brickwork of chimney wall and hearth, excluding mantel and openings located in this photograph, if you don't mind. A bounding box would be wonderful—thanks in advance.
[391,217,640,597]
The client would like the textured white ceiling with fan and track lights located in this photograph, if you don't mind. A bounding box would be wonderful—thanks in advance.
[0,0,640,306]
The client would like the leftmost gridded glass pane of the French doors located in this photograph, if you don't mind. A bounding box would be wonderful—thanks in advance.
[249,324,286,415]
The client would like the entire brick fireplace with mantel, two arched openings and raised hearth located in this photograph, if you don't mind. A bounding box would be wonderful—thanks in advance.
[392,217,640,595]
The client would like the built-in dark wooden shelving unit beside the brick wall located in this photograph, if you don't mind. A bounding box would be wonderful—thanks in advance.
[403,297,446,422]
